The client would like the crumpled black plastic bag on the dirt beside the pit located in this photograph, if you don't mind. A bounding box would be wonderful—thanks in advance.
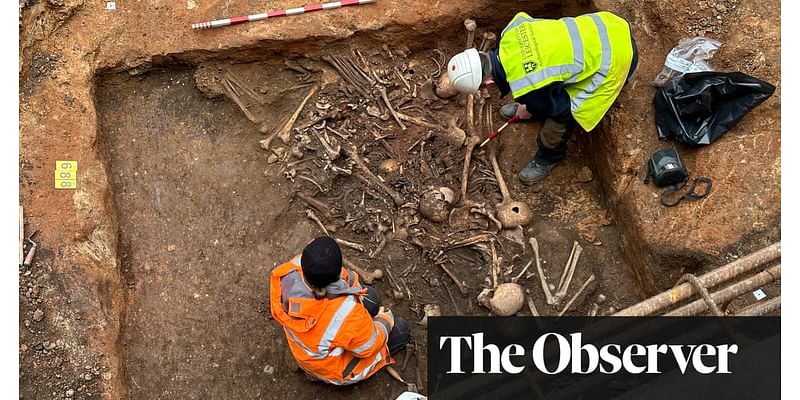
[653,71,775,146]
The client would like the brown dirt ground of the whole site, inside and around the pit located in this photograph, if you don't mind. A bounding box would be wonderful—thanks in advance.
[20,0,780,399]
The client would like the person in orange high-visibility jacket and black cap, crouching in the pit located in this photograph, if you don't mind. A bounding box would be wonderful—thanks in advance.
[269,236,411,385]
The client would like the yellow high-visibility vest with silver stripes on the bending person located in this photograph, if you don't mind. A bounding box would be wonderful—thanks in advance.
[498,11,633,132]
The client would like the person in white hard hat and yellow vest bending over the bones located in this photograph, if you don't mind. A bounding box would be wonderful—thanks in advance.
[447,12,638,184]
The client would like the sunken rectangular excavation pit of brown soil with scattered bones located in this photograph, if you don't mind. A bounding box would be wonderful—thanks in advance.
[96,3,648,398]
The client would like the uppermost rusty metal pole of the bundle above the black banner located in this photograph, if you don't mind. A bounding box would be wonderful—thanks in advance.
[614,242,781,317]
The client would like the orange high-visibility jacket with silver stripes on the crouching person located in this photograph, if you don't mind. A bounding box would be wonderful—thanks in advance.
[269,255,394,385]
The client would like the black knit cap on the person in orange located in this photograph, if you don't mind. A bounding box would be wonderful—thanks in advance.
[300,236,342,288]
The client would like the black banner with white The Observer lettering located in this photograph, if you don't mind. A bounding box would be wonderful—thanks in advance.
[428,317,780,400]
